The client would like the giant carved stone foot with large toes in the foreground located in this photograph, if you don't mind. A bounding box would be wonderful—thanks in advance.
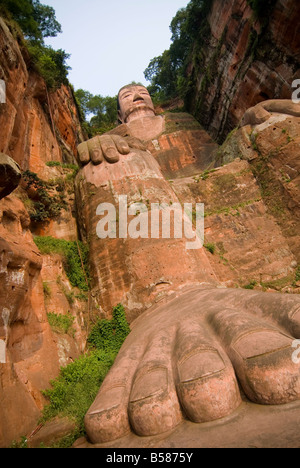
[85,289,300,444]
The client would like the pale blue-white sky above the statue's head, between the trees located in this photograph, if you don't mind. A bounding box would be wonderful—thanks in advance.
[41,0,189,96]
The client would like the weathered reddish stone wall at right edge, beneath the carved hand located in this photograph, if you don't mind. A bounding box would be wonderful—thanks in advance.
[220,109,300,263]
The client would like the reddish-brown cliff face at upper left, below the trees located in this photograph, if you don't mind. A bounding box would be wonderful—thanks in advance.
[0,18,83,178]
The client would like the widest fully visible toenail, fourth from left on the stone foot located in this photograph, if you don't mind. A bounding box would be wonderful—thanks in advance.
[232,330,292,359]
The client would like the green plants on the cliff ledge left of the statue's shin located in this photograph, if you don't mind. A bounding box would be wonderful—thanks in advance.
[34,236,89,290]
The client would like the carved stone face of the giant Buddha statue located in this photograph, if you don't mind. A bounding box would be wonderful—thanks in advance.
[118,85,155,123]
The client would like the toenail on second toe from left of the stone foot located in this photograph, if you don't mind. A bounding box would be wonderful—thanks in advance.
[130,367,168,403]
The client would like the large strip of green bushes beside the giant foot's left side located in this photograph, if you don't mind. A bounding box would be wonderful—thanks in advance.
[42,304,130,446]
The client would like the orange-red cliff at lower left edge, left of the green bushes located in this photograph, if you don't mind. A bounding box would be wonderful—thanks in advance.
[0,195,86,447]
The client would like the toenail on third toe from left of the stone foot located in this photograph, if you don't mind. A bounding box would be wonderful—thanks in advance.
[178,350,226,383]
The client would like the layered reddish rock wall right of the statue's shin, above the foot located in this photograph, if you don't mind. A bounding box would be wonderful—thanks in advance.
[173,159,295,287]
